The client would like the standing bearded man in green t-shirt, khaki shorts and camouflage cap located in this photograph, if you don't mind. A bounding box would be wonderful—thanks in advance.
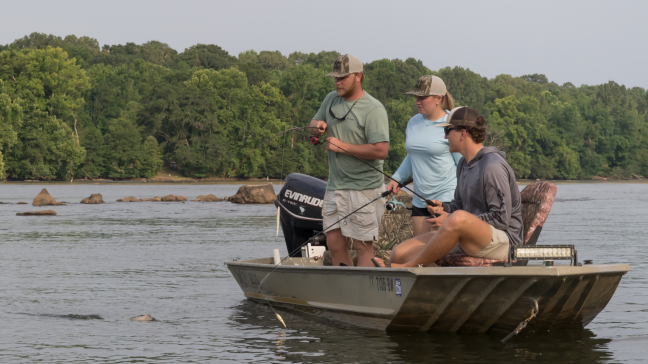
[310,54,389,267]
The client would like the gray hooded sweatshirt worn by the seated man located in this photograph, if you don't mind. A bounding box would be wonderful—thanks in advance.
[443,147,523,247]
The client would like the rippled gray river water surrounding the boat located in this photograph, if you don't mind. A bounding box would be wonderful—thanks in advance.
[0,183,648,363]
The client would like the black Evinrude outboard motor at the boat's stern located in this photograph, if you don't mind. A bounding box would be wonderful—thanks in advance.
[275,173,326,257]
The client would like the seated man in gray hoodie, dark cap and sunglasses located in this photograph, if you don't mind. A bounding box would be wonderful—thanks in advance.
[373,107,523,268]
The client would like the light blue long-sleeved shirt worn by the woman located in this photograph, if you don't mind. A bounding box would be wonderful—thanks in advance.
[392,110,462,208]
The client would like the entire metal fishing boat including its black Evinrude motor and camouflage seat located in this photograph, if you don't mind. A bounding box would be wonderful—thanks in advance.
[226,174,630,333]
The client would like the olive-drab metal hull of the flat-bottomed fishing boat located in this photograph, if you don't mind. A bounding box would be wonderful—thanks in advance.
[226,258,630,332]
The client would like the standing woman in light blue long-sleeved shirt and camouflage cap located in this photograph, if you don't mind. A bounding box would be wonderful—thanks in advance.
[387,75,461,236]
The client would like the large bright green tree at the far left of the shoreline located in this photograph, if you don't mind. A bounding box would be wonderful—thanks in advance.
[0,46,89,179]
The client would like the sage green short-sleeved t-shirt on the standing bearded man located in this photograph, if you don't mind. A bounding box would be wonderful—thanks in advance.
[313,91,389,190]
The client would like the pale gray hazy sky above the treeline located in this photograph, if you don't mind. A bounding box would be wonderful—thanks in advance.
[5,0,648,88]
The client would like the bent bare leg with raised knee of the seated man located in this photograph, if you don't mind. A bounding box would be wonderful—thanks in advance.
[392,211,493,268]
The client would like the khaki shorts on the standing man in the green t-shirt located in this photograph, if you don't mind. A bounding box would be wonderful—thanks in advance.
[322,186,385,241]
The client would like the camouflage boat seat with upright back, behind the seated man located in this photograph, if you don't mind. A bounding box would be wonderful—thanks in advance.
[436,181,558,267]
